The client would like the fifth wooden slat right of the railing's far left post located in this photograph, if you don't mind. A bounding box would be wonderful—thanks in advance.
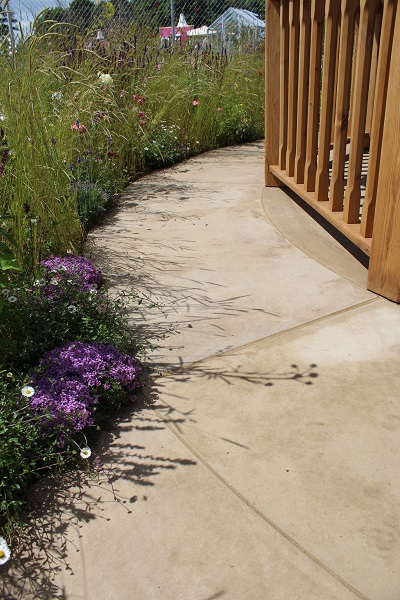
[315,0,340,201]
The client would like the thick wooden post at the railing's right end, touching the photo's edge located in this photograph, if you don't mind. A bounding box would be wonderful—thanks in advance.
[367,6,400,303]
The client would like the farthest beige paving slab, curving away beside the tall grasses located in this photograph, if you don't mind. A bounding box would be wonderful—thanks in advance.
[89,145,374,366]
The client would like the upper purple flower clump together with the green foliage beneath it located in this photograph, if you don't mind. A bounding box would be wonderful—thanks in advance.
[0,254,144,372]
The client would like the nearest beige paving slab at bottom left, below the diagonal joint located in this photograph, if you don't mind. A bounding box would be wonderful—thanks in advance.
[0,410,358,600]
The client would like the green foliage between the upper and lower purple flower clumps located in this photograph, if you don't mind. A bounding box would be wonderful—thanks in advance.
[0,270,144,372]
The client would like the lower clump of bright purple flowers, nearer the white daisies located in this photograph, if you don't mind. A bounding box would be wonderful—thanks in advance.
[29,342,141,447]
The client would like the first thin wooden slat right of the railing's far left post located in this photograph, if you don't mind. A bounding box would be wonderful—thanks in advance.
[279,0,289,171]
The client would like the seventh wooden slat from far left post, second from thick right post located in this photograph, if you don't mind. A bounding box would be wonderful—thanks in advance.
[343,0,377,223]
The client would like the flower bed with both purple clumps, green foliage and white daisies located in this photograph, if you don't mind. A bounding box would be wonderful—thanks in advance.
[0,255,143,552]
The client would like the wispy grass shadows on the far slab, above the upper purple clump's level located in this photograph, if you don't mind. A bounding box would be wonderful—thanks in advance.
[88,241,280,364]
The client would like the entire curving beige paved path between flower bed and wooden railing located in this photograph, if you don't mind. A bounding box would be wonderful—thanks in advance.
[3,143,400,600]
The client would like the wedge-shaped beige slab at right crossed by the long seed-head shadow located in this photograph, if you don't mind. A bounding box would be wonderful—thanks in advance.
[152,299,400,600]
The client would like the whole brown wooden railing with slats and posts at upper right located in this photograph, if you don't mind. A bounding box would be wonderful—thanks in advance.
[265,0,400,302]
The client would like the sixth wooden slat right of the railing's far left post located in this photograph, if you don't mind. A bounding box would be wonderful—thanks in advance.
[329,0,357,211]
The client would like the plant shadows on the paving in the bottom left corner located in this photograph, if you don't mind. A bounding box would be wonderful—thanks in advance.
[0,399,196,600]
